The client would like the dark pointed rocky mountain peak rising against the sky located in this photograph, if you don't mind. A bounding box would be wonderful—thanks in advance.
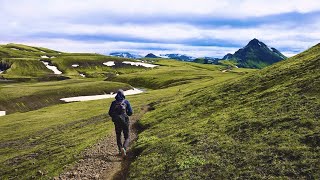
[222,39,287,69]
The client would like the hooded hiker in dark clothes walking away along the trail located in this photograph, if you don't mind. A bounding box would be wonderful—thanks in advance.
[109,89,133,158]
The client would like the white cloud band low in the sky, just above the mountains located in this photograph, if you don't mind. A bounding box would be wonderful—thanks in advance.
[10,23,320,49]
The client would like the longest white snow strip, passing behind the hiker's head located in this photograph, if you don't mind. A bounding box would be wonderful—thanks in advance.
[60,88,143,102]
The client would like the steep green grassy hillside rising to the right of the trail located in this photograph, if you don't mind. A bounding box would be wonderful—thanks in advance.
[130,45,320,179]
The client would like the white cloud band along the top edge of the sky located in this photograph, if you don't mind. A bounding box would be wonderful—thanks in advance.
[0,0,320,18]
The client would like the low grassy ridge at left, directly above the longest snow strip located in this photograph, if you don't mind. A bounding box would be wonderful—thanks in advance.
[0,79,132,113]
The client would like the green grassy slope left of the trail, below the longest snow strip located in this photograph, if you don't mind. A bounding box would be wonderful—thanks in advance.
[0,101,113,179]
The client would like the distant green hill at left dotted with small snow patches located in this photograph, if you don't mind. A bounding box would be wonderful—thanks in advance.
[0,44,148,81]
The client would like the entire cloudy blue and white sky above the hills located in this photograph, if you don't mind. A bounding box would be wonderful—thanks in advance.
[0,0,320,57]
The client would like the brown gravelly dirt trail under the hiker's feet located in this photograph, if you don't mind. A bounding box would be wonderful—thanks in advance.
[55,107,148,180]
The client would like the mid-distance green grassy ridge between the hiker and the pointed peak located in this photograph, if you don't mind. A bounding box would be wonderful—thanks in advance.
[107,59,254,89]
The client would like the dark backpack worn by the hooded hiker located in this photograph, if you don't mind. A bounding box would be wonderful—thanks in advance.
[113,100,129,125]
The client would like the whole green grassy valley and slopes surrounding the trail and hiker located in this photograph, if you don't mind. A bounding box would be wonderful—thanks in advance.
[0,44,320,179]
